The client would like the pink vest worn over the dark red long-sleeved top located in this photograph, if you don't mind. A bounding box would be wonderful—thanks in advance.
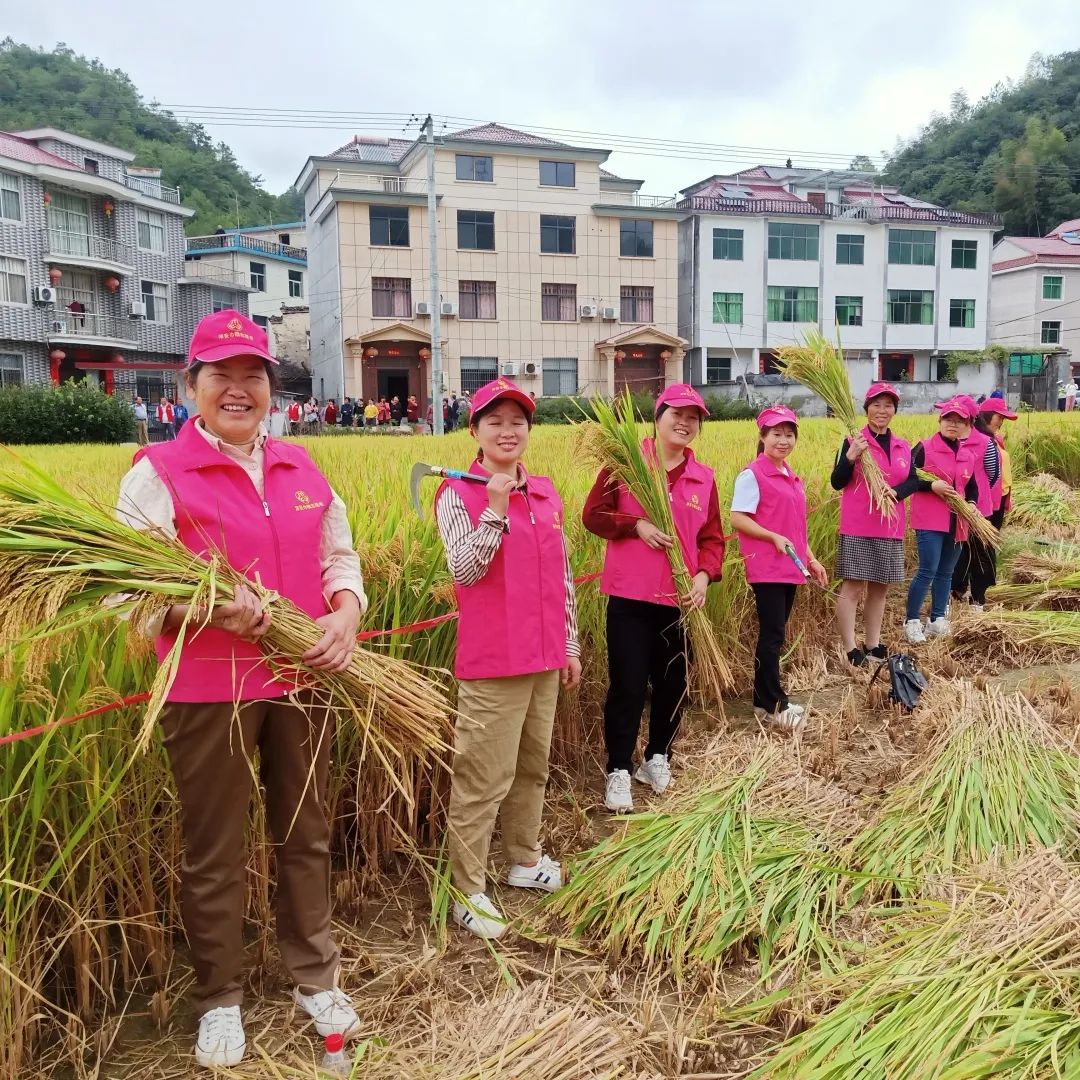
[600,438,715,607]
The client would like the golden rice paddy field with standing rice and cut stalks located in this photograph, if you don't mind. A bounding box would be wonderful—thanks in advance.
[0,414,1080,1080]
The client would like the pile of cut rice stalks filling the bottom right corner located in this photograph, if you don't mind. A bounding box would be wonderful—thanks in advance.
[741,852,1080,1080]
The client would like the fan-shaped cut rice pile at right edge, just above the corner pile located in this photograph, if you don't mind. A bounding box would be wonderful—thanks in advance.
[845,683,1080,899]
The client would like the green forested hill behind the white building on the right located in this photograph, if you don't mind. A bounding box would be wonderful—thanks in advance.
[885,52,1080,237]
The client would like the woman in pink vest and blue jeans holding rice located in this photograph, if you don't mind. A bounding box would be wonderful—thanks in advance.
[904,395,982,644]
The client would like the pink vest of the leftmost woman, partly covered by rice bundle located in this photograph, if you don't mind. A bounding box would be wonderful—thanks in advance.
[135,423,333,702]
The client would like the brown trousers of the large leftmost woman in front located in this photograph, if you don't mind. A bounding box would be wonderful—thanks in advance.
[162,698,339,1014]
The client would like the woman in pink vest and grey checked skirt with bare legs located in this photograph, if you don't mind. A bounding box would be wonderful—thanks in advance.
[829,382,915,667]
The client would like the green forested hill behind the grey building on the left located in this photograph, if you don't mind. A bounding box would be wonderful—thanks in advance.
[0,38,302,234]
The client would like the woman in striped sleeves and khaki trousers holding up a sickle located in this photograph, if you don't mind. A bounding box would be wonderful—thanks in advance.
[435,379,581,937]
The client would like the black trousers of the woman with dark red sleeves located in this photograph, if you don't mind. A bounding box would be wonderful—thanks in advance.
[604,596,687,772]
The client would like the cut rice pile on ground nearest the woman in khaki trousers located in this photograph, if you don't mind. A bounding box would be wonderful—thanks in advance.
[548,741,852,978]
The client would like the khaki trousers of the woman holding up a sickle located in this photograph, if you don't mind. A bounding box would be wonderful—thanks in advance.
[448,671,559,896]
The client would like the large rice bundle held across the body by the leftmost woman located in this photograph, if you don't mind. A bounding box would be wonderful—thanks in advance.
[0,460,450,799]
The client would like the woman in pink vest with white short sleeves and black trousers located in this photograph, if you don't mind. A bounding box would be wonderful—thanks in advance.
[731,405,828,731]
